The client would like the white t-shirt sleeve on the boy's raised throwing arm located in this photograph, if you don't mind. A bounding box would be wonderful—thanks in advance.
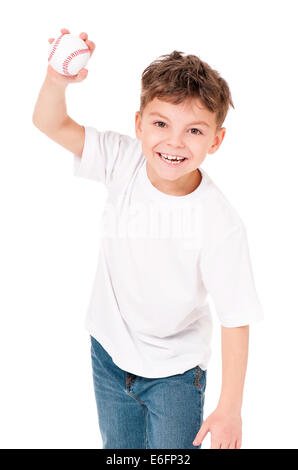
[73,126,121,185]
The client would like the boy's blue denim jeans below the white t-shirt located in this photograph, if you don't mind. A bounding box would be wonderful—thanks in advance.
[90,336,207,449]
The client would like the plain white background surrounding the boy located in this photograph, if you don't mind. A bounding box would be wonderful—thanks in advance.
[0,0,298,449]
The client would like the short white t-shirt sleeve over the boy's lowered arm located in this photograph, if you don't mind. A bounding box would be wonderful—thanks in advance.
[201,226,264,327]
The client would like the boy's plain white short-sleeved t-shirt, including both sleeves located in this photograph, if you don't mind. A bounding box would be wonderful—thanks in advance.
[73,126,263,378]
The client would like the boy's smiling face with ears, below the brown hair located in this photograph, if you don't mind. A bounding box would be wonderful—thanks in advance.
[135,98,226,182]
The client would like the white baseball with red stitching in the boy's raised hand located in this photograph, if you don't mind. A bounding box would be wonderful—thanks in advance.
[48,34,91,77]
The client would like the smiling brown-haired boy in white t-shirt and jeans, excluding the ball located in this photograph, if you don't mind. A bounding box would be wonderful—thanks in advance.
[33,29,263,449]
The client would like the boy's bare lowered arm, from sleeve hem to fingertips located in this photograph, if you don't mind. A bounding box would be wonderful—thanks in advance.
[194,325,249,449]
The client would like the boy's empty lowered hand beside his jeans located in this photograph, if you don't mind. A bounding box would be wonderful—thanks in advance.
[193,408,242,449]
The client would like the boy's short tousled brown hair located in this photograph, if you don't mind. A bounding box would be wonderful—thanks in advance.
[140,50,234,132]
